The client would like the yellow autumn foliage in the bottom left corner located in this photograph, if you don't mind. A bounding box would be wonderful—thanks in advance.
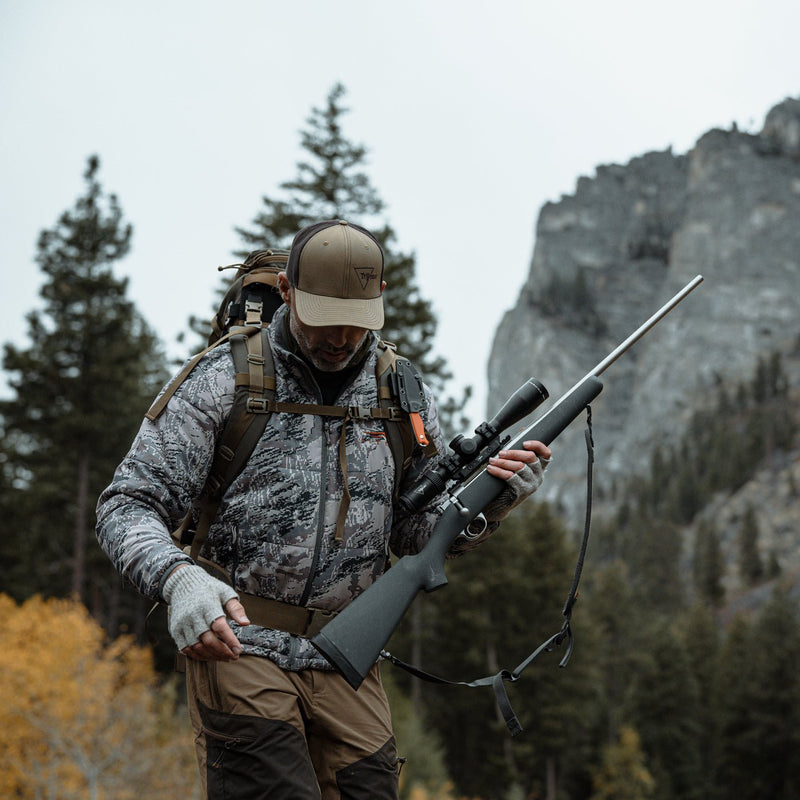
[0,595,197,800]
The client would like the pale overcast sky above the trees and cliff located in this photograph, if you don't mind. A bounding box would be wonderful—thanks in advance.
[0,0,800,424]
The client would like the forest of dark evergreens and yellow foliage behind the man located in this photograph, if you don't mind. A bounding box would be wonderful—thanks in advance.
[0,84,800,800]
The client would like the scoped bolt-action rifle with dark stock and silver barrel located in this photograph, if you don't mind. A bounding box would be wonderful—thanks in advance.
[311,275,703,689]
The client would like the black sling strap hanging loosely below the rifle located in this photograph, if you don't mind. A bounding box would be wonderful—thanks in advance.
[381,406,594,736]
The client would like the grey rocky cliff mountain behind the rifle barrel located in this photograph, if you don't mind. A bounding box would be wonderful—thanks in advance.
[488,98,800,600]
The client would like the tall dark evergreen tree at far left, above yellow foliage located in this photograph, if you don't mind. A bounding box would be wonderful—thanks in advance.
[0,156,164,623]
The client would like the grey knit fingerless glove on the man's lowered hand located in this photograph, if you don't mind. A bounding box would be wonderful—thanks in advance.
[163,564,238,650]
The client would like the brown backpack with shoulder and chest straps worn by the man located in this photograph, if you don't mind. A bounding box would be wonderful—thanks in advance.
[145,250,437,564]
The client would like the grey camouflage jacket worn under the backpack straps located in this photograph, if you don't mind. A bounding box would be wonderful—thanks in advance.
[97,308,482,669]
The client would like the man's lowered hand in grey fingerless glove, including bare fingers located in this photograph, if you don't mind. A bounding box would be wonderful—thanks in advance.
[164,564,250,661]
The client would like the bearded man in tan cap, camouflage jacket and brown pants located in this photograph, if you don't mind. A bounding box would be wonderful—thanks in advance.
[97,221,550,800]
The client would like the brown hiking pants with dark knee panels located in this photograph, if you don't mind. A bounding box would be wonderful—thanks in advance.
[186,656,398,800]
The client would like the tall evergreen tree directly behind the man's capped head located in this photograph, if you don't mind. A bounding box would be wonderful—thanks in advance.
[236,83,454,396]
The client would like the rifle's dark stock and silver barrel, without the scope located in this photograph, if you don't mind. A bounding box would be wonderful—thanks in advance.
[311,275,703,689]
